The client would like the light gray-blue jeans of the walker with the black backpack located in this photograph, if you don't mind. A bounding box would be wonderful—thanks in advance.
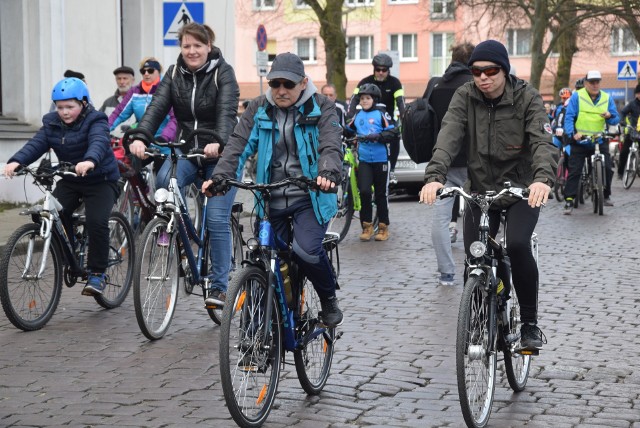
[431,167,467,275]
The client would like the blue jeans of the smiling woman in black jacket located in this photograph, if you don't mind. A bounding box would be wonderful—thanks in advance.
[156,155,238,291]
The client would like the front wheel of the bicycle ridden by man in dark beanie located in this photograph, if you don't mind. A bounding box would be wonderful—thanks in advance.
[456,276,497,428]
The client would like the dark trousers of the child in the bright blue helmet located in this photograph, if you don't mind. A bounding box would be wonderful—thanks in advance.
[53,180,119,273]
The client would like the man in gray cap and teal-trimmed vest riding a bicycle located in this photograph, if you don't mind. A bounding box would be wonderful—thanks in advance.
[202,53,342,327]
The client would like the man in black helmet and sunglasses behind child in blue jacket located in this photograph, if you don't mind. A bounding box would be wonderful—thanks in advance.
[347,53,405,184]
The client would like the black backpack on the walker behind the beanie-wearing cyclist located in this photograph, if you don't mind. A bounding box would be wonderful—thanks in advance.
[402,77,440,163]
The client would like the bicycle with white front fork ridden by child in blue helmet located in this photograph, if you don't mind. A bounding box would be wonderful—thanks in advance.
[0,163,135,331]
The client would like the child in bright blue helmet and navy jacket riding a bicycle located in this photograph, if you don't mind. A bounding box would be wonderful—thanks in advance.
[4,77,120,296]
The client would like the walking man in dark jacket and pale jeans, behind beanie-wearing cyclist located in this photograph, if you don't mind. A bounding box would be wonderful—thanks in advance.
[423,43,475,285]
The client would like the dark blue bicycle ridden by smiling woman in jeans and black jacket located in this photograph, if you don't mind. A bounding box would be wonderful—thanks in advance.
[132,129,244,340]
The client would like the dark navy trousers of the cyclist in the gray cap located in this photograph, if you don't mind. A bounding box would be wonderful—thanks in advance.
[271,199,336,298]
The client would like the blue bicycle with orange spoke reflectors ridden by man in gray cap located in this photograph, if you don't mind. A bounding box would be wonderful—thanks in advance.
[220,177,341,427]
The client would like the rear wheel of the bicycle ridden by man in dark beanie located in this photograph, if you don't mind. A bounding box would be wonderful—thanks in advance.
[502,290,531,392]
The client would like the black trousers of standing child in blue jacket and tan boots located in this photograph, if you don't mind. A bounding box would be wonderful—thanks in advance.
[358,162,389,225]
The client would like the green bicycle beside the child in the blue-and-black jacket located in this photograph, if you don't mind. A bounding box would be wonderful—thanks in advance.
[327,136,379,242]
